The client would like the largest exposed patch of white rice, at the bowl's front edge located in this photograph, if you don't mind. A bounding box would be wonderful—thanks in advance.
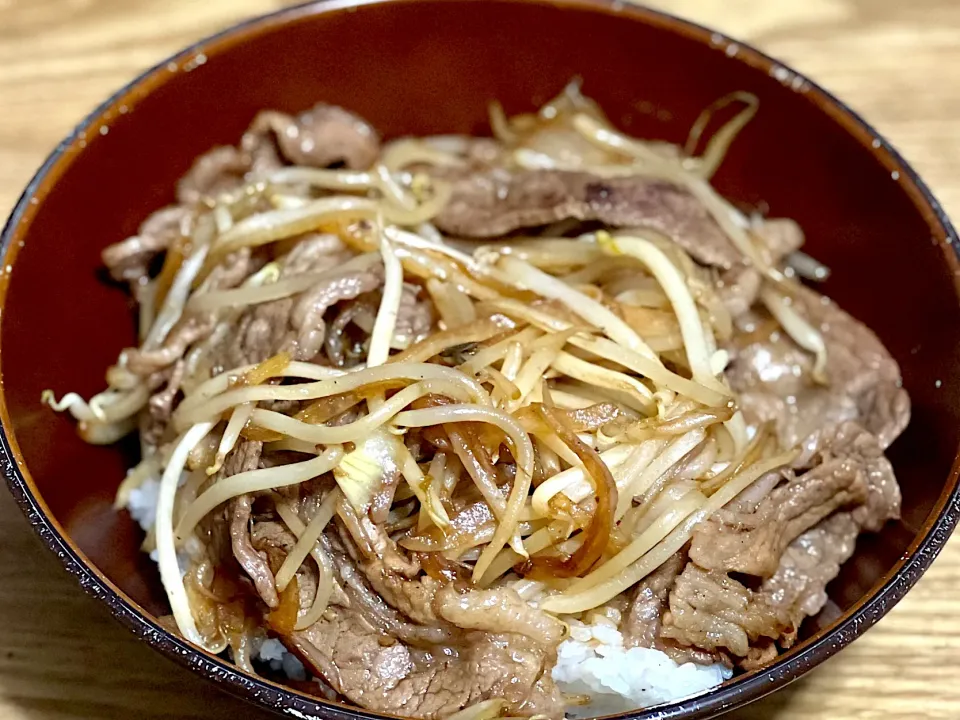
[553,620,733,718]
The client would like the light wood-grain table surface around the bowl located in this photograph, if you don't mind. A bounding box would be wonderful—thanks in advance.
[0,0,960,720]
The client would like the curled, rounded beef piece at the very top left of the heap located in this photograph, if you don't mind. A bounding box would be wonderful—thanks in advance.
[240,103,380,170]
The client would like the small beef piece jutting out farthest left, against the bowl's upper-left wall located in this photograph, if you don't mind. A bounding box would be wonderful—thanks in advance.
[101,205,193,284]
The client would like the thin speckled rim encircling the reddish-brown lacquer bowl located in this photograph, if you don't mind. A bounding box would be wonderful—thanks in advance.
[0,0,960,720]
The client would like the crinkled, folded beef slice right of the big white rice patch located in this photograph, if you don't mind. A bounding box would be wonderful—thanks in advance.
[662,423,900,668]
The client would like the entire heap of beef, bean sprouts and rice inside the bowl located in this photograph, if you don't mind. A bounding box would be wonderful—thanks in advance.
[43,83,910,720]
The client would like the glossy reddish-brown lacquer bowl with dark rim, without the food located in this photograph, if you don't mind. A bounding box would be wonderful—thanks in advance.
[0,0,960,720]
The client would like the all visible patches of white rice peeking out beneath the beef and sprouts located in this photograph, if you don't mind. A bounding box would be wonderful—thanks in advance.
[127,478,733,719]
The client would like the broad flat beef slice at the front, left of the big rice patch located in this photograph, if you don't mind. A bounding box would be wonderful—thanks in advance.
[283,521,563,720]
